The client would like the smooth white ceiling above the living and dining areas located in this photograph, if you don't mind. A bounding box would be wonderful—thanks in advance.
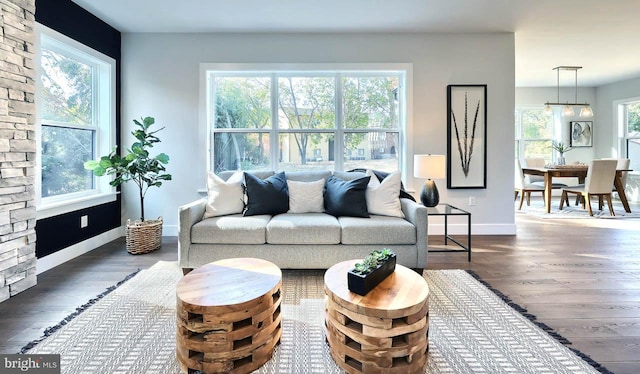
[73,0,640,87]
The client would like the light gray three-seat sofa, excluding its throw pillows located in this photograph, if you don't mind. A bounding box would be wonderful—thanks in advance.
[178,171,427,271]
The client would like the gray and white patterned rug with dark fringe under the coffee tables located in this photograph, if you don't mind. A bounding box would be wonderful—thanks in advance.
[24,261,598,373]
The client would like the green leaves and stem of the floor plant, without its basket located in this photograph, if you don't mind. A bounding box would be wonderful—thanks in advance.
[84,117,171,222]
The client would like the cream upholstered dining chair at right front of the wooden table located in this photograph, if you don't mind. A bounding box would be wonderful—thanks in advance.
[560,160,618,216]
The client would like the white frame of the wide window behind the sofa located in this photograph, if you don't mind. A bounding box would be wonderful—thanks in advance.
[199,63,413,176]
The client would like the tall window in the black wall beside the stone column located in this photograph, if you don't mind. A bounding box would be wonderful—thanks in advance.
[36,26,115,216]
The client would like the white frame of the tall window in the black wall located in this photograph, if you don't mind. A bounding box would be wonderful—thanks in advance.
[34,23,117,219]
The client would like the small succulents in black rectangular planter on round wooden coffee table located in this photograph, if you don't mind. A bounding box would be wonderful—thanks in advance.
[347,248,396,296]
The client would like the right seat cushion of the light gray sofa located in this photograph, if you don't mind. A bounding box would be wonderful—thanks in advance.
[338,215,416,244]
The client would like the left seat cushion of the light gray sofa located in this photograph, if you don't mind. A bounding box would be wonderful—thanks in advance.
[191,214,271,244]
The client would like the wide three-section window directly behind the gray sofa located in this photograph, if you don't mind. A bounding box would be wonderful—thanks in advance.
[206,70,405,172]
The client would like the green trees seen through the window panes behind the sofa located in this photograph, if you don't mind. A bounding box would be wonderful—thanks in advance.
[214,75,398,172]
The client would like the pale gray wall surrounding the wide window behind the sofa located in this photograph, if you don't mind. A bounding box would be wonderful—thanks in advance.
[122,33,515,235]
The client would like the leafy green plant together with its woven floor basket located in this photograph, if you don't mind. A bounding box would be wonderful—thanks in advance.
[84,117,171,254]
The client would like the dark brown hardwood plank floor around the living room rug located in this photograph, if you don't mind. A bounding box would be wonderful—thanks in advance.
[0,204,640,374]
